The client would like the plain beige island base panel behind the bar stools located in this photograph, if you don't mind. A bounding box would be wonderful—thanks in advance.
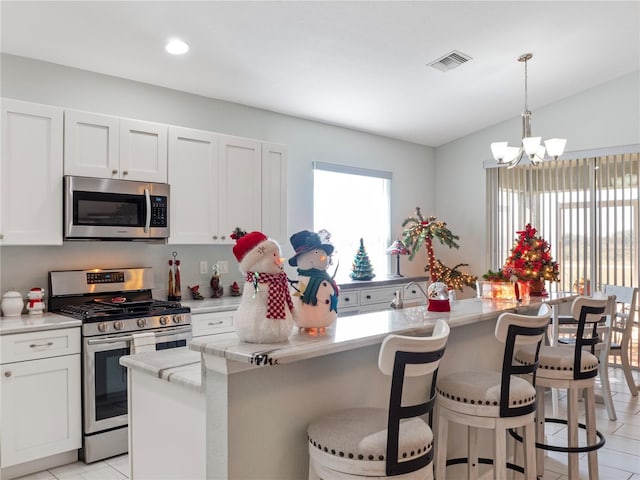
[204,315,502,480]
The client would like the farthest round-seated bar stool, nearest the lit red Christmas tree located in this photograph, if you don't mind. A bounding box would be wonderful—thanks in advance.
[516,297,608,480]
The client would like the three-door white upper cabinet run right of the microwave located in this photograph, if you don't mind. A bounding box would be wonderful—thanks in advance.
[168,127,288,244]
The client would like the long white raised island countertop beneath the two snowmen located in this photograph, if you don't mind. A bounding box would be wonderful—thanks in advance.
[189,293,575,366]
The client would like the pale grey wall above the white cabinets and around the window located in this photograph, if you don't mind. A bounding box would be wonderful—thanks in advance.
[0,54,435,295]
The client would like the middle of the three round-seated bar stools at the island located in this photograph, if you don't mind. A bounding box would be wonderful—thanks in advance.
[436,304,551,480]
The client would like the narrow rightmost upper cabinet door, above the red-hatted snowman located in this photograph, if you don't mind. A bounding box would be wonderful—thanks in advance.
[262,143,289,245]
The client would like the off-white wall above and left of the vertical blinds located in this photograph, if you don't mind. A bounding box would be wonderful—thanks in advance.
[435,72,640,284]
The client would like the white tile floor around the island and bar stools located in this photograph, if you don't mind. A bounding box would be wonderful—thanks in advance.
[12,368,640,480]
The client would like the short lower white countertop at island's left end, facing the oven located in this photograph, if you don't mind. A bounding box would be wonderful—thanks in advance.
[120,347,204,392]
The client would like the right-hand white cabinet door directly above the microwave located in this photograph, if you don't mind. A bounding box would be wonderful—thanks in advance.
[120,119,167,183]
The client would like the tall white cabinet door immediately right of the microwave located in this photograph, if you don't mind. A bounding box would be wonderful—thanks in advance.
[169,127,218,244]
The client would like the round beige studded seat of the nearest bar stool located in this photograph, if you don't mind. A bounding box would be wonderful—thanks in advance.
[308,408,433,477]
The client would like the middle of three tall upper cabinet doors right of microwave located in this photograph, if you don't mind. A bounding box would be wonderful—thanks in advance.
[218,135,262,243]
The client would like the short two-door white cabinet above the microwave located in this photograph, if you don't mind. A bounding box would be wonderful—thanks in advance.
[64,110,167,183]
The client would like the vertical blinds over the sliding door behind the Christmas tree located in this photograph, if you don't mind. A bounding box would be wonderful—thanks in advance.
[487,152,640,291]
